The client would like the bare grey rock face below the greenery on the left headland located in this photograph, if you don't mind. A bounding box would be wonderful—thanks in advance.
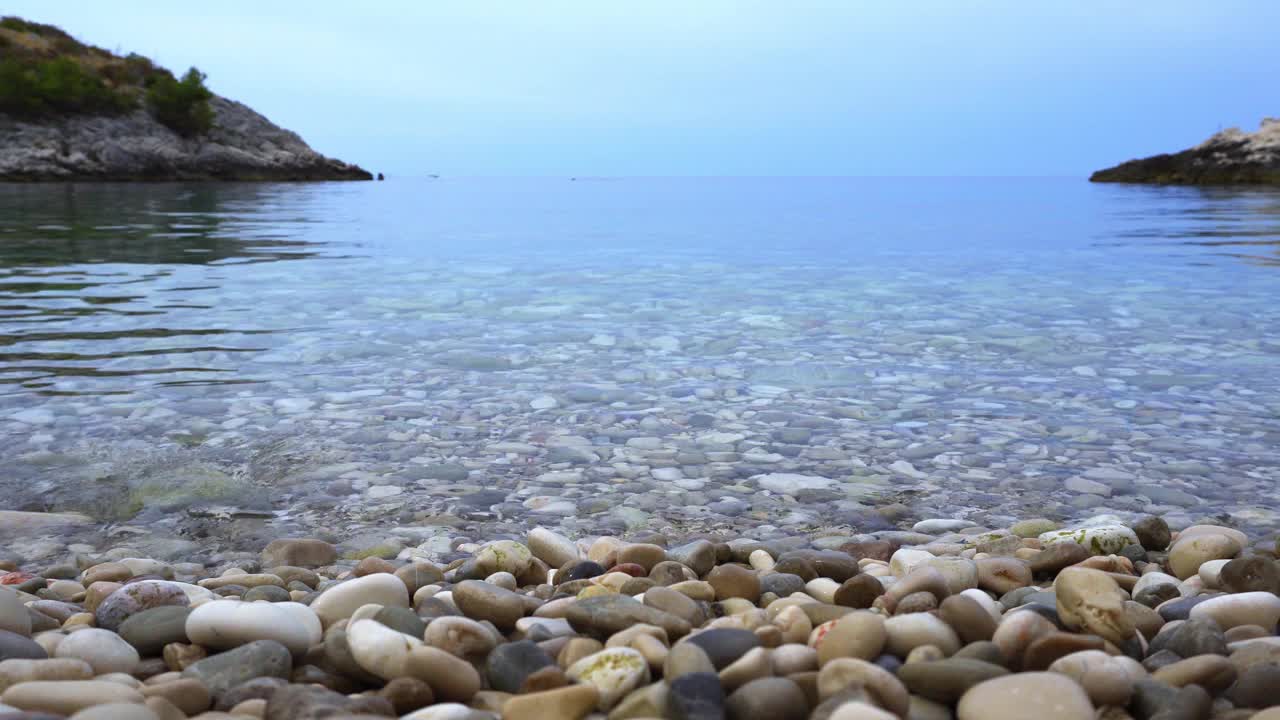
[0,96,372,181]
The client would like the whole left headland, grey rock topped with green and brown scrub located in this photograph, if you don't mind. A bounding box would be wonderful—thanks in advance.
[0,17,372,182]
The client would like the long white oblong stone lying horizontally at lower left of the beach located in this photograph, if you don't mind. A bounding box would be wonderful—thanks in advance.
[187,600,324,656]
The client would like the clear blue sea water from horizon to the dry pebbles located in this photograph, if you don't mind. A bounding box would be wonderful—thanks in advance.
[0,178,1280,543]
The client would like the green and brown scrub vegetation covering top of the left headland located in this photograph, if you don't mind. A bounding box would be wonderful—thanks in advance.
[0,17,214,137]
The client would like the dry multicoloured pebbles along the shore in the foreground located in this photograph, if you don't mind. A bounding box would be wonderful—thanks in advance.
[0,515,1280,720]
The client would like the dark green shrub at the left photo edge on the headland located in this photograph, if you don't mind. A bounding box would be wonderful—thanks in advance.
[0,58,134,117]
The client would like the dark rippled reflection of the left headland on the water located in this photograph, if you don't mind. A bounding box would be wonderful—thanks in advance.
[0,184,340,395]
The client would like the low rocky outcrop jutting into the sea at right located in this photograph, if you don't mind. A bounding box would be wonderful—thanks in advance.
[1089,118,1280,184]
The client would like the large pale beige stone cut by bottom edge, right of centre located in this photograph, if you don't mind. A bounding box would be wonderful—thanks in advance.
[956,673,1093,720]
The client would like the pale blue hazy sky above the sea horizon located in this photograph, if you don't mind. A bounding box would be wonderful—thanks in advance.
[0,0,1280,176]
